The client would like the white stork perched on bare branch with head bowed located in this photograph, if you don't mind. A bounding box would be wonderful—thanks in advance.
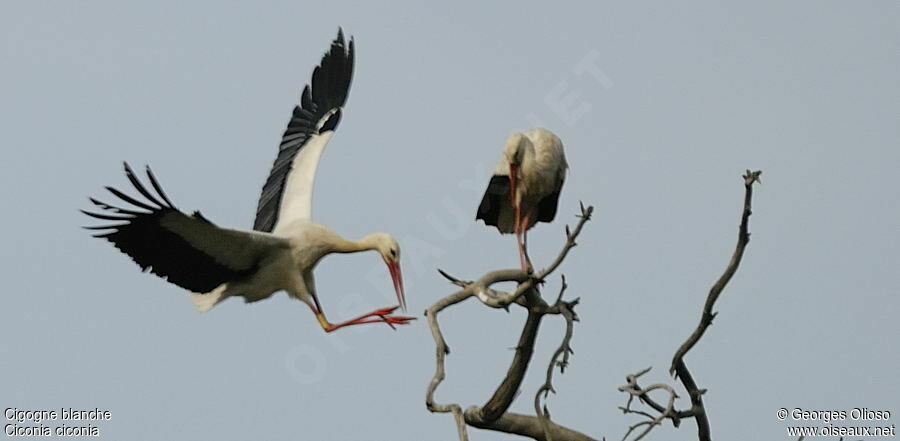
[475,129,569,270]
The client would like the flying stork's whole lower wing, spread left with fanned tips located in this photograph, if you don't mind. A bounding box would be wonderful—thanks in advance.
[81,163,288,293]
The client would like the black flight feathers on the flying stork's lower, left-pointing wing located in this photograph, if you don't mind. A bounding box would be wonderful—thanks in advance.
[82,163,259,292]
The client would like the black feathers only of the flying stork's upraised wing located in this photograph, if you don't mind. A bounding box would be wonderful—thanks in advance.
[253,29,353,232]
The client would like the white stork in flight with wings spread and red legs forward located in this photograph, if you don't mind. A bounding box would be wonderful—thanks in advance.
[82,30,414,332]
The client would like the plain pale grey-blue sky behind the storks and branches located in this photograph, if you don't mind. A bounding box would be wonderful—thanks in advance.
[0,1,900,441]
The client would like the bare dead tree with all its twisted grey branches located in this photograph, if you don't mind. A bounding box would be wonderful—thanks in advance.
[425,170,761,441]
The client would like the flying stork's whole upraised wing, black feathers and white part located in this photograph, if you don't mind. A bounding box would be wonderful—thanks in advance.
[253,30,353,232]
